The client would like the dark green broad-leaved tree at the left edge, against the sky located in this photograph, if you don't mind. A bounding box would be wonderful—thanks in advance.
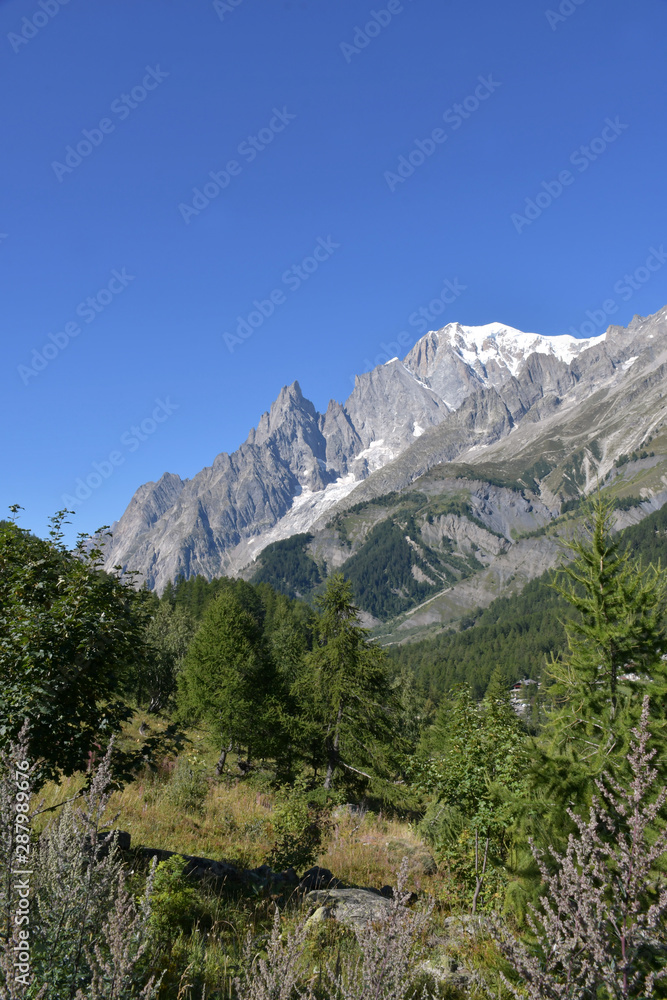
[0,506,157,785]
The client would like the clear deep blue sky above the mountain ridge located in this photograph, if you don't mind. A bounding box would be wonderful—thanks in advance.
[0,0,667,548]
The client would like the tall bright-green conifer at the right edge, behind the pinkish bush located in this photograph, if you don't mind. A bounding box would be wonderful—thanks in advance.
[512,494,667,912]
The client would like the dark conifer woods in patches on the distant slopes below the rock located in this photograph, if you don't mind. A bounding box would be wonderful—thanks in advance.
[174,498,667,701]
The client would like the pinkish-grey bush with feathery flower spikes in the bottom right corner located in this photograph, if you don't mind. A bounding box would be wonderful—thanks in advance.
[489,697,667,1000]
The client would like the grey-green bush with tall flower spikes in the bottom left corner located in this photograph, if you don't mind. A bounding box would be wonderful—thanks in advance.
[0,726,159,1000]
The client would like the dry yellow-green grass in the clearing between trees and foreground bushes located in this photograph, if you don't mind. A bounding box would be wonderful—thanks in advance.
[23,712,488,1000]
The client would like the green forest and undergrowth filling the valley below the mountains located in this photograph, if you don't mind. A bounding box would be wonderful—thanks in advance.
[0,497,667,1000]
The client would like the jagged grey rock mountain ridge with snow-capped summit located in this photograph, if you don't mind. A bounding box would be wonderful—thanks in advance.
[100,307,667,592]
